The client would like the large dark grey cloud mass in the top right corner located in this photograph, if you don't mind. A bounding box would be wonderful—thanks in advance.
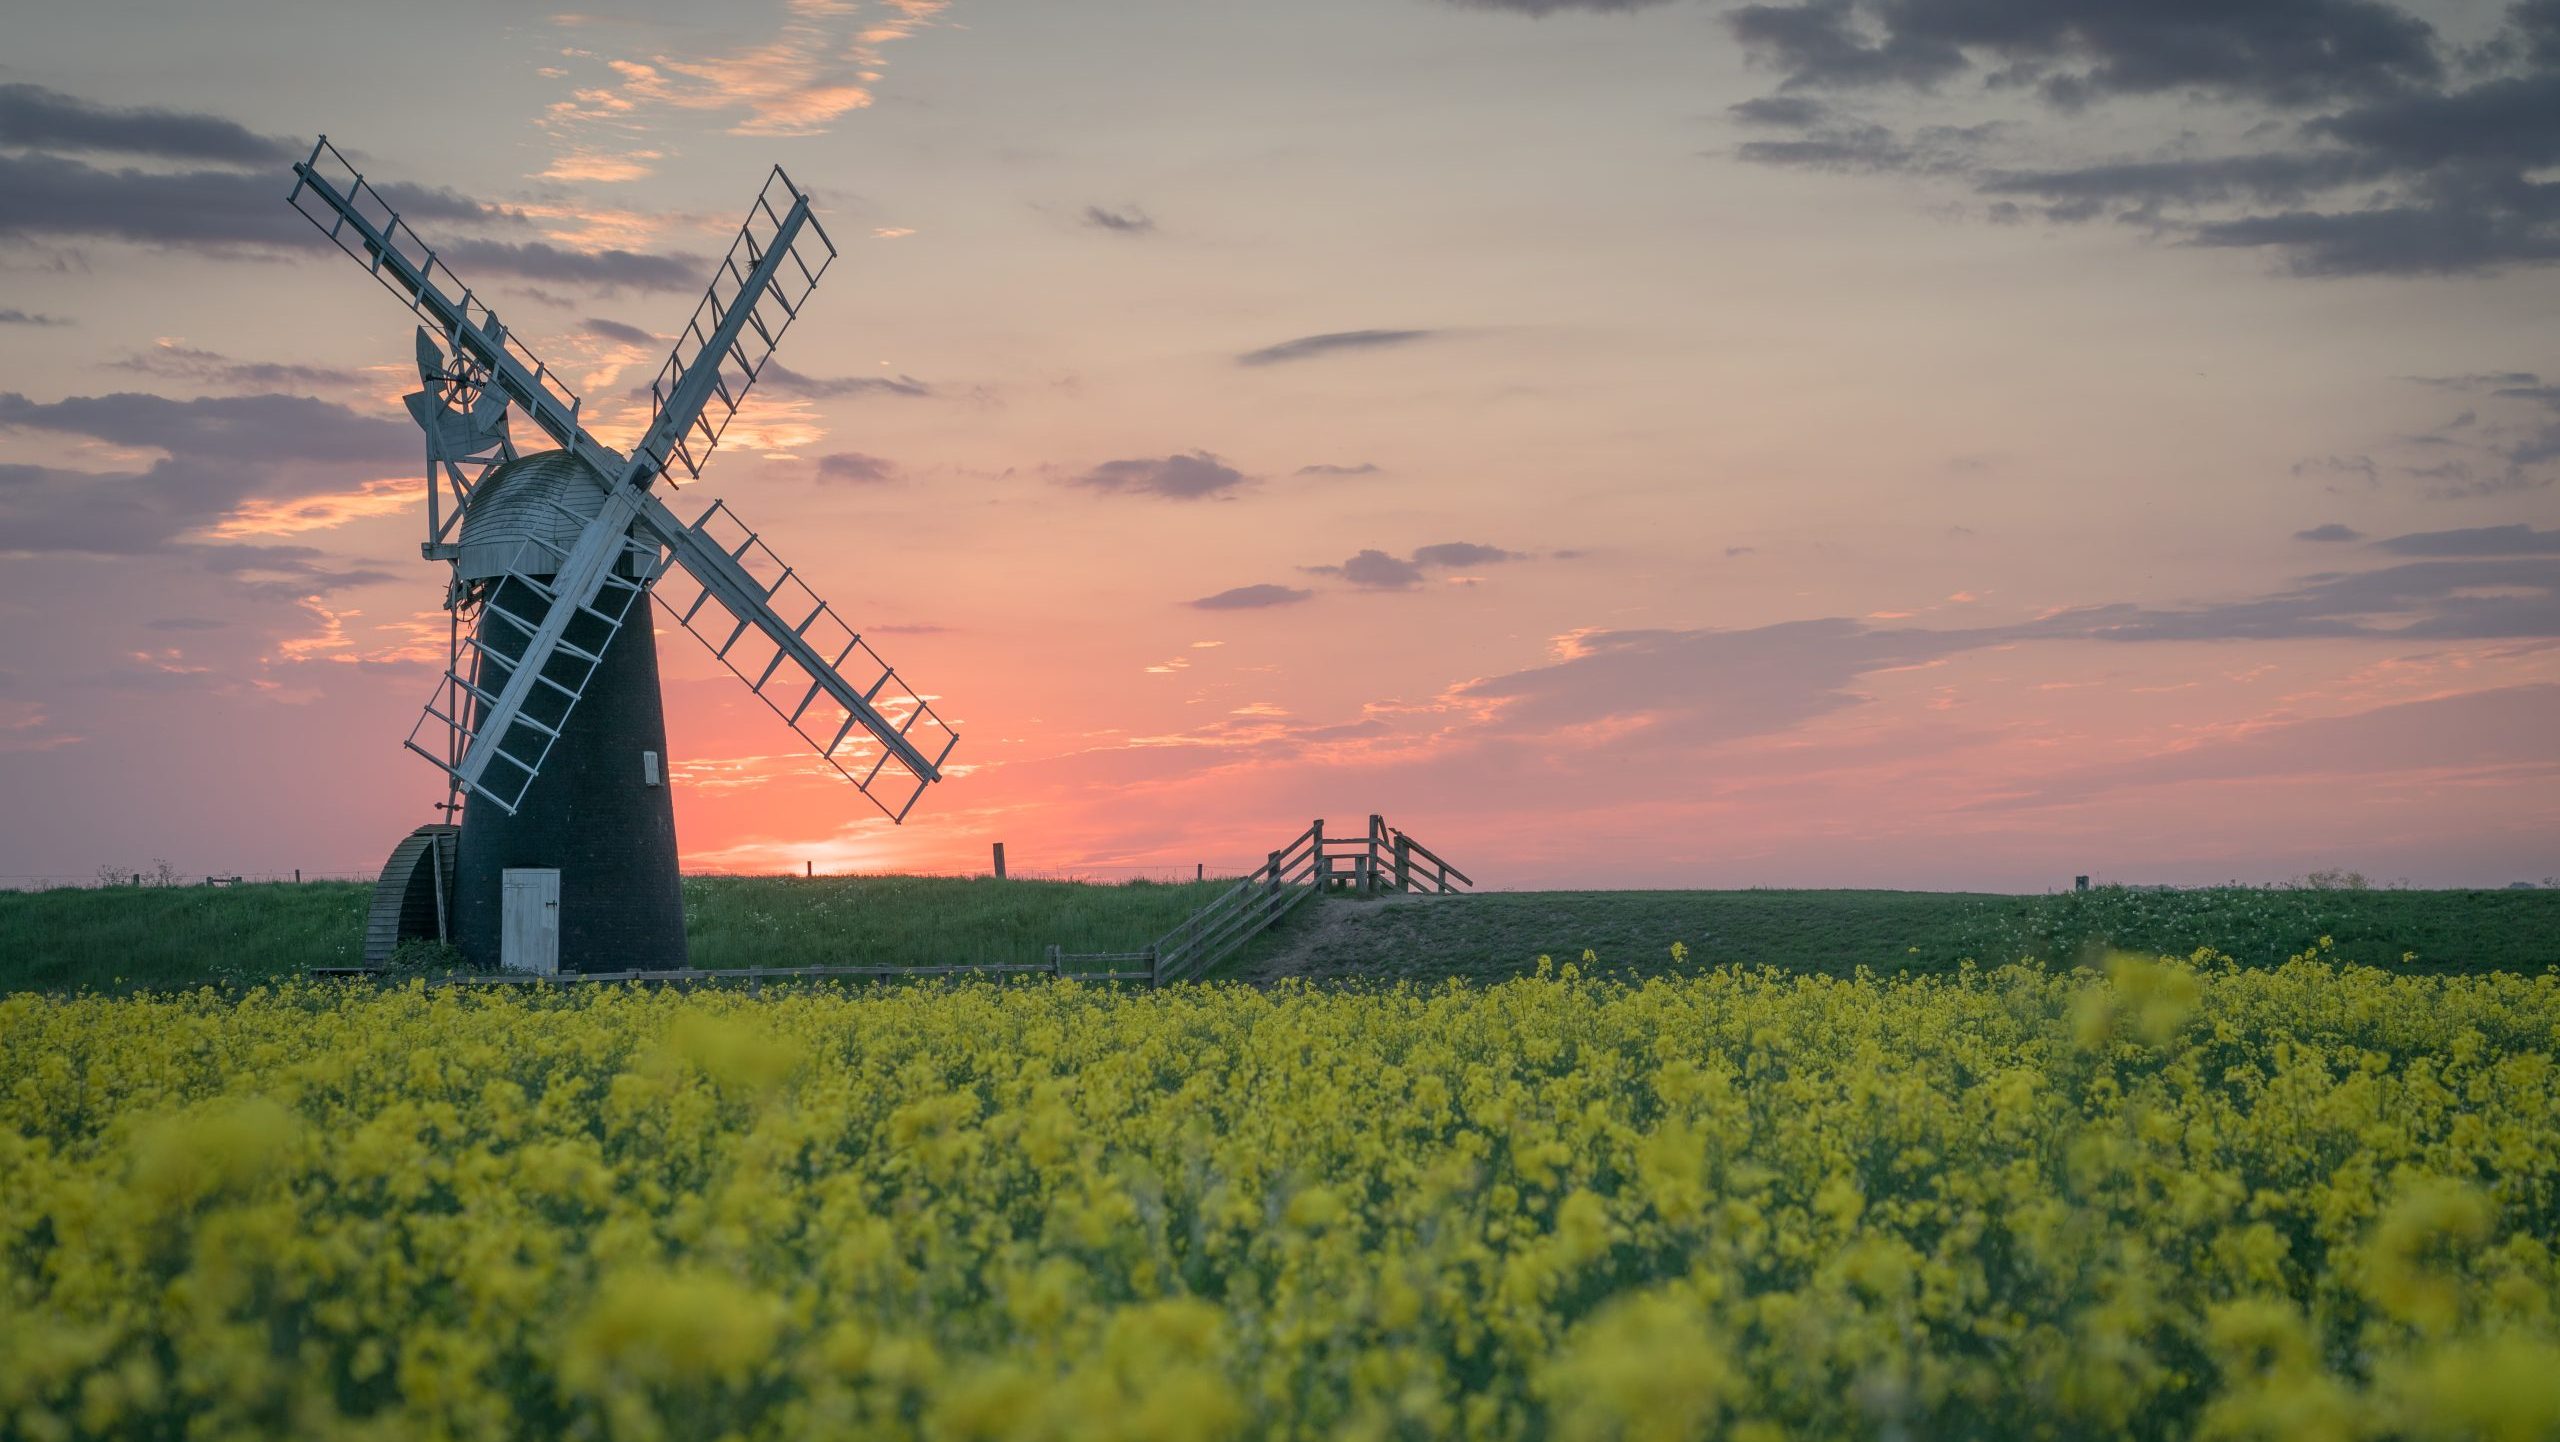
[1728,0,2560,277]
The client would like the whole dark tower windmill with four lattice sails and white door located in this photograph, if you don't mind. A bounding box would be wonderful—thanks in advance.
[287,136,960,971]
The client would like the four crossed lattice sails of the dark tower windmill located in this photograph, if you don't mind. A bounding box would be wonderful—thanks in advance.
[289,138,957,820]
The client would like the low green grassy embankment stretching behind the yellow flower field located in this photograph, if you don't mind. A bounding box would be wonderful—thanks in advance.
[0,876,2560,991]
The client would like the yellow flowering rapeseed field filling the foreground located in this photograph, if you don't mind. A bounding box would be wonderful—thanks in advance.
[0,953,2560,1442]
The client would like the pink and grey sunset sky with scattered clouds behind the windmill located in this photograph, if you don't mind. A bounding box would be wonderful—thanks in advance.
[0,0,2560,891]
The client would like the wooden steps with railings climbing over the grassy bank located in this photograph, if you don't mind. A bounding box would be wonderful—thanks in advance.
[1050,814,1475,986]
